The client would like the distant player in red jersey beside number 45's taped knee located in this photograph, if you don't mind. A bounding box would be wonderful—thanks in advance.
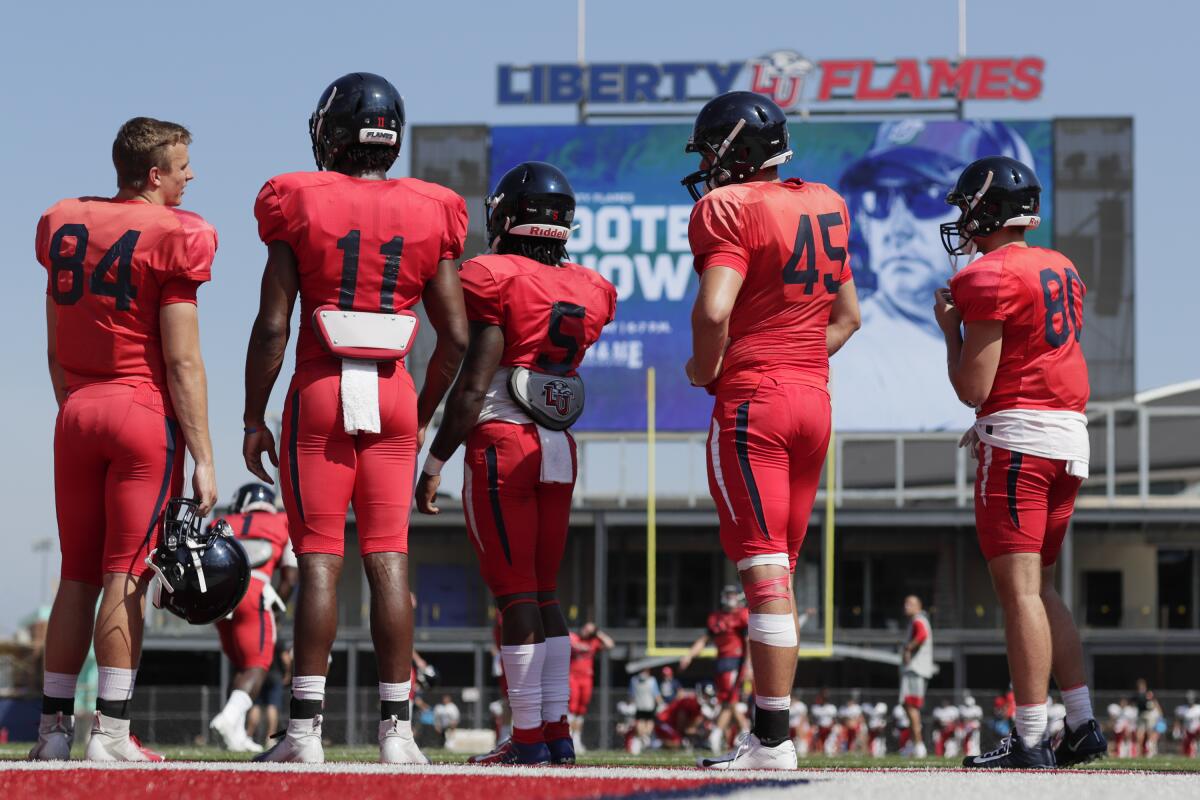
[679,587,748,752]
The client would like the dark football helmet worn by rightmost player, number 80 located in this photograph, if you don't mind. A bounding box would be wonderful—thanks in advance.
[941,156,1042,255]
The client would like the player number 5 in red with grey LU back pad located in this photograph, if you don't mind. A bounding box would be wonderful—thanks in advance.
[416,161,617,764]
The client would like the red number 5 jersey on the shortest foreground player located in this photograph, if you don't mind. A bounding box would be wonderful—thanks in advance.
[458,255,617,375]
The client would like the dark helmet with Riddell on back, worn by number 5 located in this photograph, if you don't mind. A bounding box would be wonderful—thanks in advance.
[484,161,575,251]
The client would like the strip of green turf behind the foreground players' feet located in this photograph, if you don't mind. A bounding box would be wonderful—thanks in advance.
[0,744,1200,772]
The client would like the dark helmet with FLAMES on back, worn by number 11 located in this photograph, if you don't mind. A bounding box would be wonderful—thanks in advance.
[308,72,404,169]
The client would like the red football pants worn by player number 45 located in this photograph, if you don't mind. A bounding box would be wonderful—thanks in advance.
[708,375,829,571]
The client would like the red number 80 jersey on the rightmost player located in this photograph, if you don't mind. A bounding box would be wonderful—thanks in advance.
[950,245,1091,416]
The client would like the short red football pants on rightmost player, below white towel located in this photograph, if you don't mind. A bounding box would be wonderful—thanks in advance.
[976,443,1082,566]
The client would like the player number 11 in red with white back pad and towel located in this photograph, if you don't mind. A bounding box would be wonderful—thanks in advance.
[242,72,467,763]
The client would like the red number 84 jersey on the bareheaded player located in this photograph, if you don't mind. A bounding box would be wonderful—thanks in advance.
[37,197,217,392]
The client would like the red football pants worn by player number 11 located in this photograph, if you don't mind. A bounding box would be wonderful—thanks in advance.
[280,357,416,555]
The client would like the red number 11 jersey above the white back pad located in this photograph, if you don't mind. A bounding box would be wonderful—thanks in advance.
[254,172,467,365]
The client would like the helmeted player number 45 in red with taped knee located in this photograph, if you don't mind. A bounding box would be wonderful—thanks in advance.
[683,91,860,769]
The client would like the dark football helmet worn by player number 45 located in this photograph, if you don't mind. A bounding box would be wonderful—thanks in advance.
[679,91,792,200]
